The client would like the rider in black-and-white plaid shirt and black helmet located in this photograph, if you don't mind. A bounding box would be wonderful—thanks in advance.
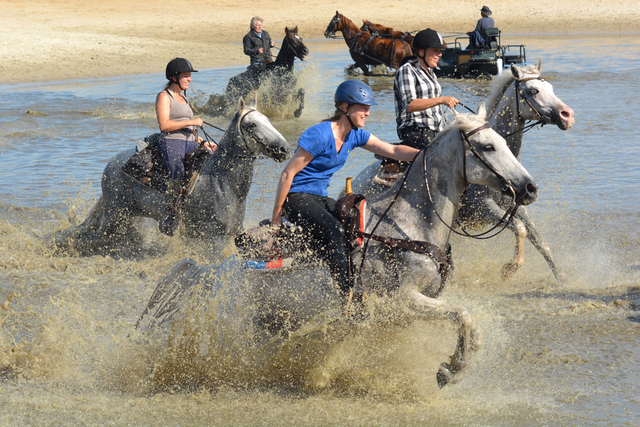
[393,28,459,154]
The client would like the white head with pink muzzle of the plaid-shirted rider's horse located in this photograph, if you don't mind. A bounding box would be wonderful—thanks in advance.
[511,59,575,130]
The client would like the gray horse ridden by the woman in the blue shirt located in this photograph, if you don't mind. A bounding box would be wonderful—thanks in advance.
[138,105,537,386]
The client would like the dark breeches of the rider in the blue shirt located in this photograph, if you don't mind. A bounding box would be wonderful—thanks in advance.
[284,193,352,293]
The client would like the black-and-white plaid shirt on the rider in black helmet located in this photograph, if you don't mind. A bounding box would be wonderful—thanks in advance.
[393,59,444,136]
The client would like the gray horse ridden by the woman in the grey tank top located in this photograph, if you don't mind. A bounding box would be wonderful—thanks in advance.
[56,98,291,255]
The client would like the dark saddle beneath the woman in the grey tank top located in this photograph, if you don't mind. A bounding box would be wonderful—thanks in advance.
[122,133,210,193]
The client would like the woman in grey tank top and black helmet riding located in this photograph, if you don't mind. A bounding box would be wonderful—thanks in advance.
[156,58,215,236]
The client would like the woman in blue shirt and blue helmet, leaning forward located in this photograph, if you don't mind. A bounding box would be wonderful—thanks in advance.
[271,80,419,304]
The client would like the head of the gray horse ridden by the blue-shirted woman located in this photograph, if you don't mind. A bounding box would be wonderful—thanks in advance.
[451,103,538,205]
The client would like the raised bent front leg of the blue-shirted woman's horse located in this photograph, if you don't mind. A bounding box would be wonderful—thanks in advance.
[402,289,480,388]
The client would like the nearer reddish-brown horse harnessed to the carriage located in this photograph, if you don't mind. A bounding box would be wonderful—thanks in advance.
[324,11,412,76]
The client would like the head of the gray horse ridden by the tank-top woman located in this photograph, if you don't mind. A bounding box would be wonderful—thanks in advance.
[237,96,291,162]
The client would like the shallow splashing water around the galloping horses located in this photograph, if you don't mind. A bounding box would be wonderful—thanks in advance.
[0,34,640,426]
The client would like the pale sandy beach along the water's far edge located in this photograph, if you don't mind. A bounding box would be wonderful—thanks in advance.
[0,0,640,83]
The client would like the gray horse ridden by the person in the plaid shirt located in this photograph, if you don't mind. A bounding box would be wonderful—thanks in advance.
[353,60,574,282]
